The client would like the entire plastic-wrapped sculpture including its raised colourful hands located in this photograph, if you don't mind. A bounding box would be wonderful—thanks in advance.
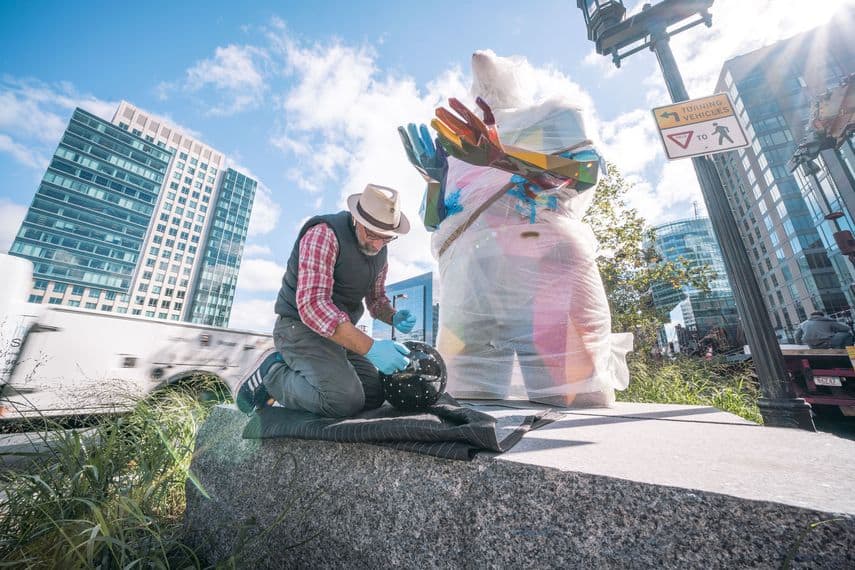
[399,52,632,406]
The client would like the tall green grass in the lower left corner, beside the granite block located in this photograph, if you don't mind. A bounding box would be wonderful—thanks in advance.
[0,378,222,569]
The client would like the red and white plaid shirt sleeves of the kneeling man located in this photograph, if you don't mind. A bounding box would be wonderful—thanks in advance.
[297,224,395,337]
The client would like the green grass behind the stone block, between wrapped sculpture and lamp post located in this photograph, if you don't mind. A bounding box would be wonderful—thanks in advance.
[617,355,763,423]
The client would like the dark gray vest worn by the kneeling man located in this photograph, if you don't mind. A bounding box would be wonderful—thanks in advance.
[276,211,386,324]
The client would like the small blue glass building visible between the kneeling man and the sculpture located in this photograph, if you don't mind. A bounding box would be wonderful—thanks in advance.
[372,272,436,345]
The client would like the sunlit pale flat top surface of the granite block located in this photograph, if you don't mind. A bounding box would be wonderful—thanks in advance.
[469,402,855,514]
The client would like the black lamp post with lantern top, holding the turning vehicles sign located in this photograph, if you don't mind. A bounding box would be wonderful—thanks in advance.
[576,0,815,431]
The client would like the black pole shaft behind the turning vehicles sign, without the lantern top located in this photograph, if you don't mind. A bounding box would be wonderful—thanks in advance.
[650,26,815,431]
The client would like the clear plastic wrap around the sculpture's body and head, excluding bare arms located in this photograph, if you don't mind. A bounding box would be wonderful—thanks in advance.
[431,53,633,406]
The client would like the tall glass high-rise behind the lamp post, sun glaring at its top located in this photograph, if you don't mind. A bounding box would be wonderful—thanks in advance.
[715,10,855,341]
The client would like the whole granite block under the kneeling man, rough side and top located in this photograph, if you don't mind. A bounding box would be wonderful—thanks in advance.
[185,402,855,570]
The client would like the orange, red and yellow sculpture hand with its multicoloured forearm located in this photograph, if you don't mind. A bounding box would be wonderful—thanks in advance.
[431,97,599,190]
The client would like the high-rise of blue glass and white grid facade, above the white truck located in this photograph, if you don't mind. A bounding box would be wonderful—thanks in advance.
[9,101,257,326]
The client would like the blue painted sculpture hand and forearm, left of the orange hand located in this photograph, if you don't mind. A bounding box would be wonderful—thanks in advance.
[398,123,448,230]
